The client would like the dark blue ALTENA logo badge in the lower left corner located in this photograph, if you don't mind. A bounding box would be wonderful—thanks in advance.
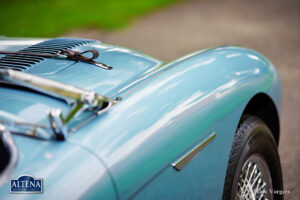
[10,175,43,193]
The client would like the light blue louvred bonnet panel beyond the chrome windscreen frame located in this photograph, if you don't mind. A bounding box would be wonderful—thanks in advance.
[0,38,162,96]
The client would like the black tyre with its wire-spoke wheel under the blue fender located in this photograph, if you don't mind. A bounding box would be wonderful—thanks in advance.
[223,115,283,200]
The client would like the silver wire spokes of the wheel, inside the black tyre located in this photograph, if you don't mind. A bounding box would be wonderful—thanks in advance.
[235,154,273,200]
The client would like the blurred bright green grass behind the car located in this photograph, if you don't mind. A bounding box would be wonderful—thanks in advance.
[0,0,180,37]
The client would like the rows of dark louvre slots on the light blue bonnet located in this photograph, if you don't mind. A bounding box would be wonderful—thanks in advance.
[0,38,96,71]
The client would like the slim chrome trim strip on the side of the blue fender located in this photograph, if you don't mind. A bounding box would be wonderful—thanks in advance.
[172,132,216,171]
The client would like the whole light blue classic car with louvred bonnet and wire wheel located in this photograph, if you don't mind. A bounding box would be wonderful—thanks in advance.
[0,38,283,200]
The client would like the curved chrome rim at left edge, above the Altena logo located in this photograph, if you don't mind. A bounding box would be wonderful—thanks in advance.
[0,124,18,186]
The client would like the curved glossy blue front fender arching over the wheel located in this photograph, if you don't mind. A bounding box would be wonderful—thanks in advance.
[69,47,280,199]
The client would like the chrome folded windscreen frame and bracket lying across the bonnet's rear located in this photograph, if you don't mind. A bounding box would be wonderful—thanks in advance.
[0,69,121,140]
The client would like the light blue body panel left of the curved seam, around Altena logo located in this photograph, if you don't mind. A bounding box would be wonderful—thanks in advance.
[0,135,116,200]
